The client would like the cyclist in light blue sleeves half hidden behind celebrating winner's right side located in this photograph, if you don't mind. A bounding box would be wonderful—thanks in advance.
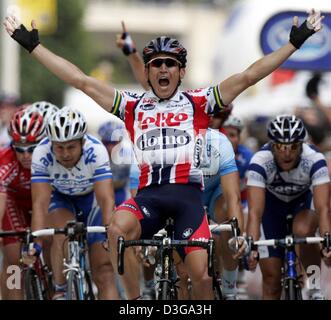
[201,128,243,300]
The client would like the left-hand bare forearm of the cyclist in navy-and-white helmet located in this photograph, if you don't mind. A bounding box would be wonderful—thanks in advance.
[247,186,265,240]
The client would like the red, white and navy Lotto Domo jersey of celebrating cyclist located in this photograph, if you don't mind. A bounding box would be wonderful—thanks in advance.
[111,86,224,189]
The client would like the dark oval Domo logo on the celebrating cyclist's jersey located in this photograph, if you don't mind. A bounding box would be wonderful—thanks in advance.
[136,128,191,151]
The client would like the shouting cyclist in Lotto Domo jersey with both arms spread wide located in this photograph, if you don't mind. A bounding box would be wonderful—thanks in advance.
[4,10,324,299]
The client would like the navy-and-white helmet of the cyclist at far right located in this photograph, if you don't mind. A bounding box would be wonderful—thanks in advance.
[268,115,307,143]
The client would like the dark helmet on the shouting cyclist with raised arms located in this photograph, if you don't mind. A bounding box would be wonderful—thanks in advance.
[143,36,187,68]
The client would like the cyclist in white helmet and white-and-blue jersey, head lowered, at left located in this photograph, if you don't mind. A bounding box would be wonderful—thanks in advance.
[31,107,118,299]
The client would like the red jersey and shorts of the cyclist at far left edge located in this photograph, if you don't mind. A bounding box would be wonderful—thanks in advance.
[0,147,32,245]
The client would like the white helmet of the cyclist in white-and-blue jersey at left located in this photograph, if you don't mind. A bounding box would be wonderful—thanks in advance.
[46,107,87,142]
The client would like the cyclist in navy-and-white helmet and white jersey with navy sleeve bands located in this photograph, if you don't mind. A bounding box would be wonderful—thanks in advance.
[247,115,331,299]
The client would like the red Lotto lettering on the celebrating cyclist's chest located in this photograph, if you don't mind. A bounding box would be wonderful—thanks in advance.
[138,112,188,130]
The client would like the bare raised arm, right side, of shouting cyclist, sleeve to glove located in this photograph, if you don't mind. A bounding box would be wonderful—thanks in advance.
[219,43,297,105]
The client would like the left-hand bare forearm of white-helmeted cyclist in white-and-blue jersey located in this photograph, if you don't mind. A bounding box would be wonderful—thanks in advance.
[31,182,52,235]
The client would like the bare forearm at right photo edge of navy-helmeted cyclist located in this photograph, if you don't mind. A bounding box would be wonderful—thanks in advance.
[313,183,331,235]
